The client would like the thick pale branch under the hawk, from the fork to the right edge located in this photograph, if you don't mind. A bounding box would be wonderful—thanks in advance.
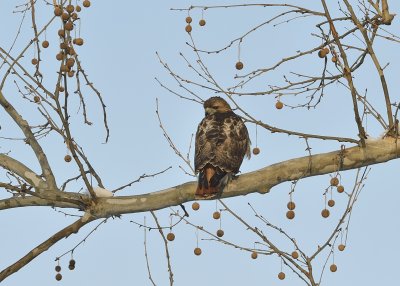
[91,138,400,217]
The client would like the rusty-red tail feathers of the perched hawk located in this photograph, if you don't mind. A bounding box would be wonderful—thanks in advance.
[196,164,228,198]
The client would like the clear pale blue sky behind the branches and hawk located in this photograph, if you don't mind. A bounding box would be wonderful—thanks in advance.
[0,0,400,286]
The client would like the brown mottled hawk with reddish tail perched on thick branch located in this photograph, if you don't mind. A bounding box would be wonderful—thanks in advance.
[194,96,250,197]
